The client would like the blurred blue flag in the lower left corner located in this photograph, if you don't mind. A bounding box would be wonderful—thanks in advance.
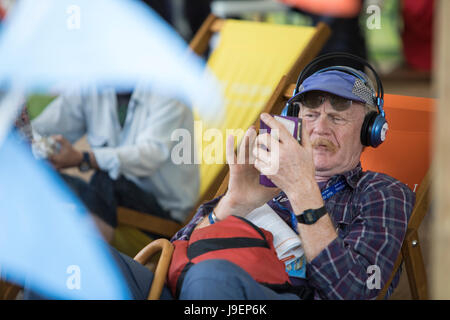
[0,134,131,299]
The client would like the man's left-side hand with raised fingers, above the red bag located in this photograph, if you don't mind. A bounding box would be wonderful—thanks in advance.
[215,126,280,220]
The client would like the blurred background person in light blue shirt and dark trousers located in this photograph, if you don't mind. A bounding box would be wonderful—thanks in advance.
[32,84,199,240]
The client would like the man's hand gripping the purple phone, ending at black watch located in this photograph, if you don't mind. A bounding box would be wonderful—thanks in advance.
[253,114,323,213]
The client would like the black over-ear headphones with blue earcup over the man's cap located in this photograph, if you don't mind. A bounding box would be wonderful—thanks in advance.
[281,52,388,148]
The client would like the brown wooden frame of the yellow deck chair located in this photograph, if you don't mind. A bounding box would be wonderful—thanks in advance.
[117,14,331,237]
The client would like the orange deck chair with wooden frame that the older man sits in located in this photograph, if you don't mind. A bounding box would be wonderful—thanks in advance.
[142,89,434,299]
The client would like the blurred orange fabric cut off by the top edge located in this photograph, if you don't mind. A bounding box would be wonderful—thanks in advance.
[279,0,362,18]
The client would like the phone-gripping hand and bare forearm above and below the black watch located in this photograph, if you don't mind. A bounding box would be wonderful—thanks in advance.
[253,114,337,262]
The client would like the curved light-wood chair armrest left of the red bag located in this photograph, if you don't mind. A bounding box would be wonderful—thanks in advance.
[134,239,174,300]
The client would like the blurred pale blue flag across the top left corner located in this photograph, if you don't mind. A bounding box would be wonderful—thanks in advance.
[0,0,223,119]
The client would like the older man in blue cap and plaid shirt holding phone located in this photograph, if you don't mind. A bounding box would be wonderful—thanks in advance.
[164,63,415,299]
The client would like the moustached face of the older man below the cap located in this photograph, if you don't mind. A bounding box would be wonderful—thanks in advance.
[299,92,365,176]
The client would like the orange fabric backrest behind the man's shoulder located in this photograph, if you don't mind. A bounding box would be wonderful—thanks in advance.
[361,94,435,191]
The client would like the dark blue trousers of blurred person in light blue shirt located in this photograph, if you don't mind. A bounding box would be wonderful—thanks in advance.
[61,171,172,228]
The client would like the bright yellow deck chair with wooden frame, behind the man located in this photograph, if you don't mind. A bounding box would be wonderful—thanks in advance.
[112,15,330,256]
